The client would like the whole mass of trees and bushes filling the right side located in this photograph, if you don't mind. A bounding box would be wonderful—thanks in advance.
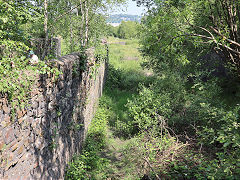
[133,0,240,179]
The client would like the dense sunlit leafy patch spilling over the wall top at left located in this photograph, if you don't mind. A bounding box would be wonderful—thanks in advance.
[0,40,60,118]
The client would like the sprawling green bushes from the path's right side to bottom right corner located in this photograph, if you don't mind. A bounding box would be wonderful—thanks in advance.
[127,69,240,179]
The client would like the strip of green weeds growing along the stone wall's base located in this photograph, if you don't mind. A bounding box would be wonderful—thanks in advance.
[65,107,109,179]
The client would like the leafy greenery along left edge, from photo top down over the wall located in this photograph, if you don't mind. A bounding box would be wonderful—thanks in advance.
[0,1,60,117]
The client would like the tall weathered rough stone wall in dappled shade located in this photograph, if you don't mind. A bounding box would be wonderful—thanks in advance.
[0,47,105,179]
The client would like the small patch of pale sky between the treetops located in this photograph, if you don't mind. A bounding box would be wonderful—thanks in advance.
[111,0,144,15]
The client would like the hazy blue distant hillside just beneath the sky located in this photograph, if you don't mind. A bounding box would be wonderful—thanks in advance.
[107,14,142,23]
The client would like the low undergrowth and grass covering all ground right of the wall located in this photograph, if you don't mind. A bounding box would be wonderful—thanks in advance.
[67,37,240,179]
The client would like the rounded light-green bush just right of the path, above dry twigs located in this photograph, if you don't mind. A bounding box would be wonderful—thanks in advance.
[127,71,186,130]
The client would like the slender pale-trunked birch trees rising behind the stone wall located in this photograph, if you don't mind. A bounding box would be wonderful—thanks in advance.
[21,0,124,56]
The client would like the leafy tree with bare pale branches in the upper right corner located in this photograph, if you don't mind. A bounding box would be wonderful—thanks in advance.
[137,0,240,74]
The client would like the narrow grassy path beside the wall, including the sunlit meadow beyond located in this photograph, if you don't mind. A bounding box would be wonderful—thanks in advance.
[96,38,153,179]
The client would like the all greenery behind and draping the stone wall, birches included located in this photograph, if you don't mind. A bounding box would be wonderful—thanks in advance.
[0,0,122,115]
